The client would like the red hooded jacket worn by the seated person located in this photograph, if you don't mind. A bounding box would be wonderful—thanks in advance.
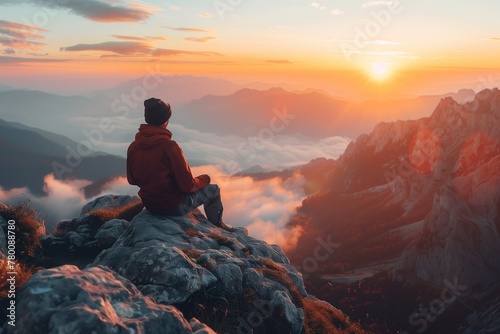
[127,124,210,214]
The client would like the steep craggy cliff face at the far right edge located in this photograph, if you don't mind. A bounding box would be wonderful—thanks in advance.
[397,89,500,288]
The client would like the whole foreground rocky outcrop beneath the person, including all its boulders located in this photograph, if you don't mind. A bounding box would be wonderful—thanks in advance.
[0,195,362,334]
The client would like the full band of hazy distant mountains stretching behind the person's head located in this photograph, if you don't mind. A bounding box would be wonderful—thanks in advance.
[0,74,474,155]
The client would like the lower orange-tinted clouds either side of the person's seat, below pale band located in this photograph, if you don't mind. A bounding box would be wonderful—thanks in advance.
[0,166,305,249]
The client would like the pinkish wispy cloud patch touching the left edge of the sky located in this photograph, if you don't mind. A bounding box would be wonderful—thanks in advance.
[0,20,47,54]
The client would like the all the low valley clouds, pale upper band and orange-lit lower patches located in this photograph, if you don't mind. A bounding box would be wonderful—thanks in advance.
[0,119,350,249]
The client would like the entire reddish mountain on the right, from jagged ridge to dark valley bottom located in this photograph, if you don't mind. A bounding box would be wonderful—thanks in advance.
[288,89,500,333]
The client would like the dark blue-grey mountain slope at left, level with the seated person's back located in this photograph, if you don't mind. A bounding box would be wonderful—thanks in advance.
[0,120,125,194]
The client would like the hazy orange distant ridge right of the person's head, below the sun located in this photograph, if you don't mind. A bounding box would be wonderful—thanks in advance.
[176,87,474,139]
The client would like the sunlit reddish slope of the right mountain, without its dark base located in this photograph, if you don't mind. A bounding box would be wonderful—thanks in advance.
[290,89,500,288]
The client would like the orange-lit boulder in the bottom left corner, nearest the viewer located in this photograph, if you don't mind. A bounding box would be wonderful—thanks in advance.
[4,265,214,334]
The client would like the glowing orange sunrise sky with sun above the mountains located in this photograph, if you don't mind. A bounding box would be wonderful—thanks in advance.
[0,0,500,95]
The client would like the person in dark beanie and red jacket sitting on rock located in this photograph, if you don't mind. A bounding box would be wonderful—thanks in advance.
[127,98,234,230]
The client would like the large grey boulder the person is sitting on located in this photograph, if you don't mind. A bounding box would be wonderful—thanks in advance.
[90,211,307,333]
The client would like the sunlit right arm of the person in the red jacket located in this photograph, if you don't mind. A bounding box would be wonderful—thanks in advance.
[169,142,210,193]
